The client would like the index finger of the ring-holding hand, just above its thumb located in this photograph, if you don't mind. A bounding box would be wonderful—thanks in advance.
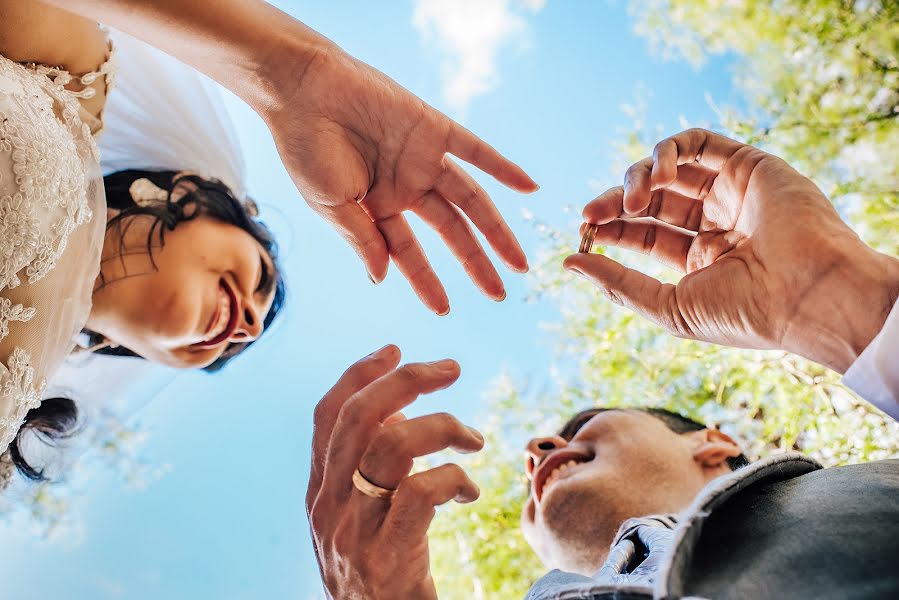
[593,219,693,273]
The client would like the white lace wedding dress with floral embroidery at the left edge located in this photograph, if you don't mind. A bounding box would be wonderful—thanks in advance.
[0,51,113,452]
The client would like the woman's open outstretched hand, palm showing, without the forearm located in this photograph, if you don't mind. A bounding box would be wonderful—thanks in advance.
[266,44,537,314]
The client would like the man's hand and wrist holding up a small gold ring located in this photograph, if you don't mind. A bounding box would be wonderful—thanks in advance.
[565,129,899,372]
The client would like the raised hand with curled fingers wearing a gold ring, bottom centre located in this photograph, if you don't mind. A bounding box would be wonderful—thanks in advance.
[306,346,484,600]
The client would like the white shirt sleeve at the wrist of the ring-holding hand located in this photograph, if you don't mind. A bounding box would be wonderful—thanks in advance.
[843,302,899,420]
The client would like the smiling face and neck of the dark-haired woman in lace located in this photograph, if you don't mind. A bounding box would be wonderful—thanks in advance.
[87,171,280,368]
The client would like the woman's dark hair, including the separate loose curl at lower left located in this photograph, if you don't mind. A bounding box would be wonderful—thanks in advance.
[9,170,285,481]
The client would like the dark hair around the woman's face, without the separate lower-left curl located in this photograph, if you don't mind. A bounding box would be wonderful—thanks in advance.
[85,170,285,373]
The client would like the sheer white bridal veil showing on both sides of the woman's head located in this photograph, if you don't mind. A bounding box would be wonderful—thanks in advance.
[45,30,246,437]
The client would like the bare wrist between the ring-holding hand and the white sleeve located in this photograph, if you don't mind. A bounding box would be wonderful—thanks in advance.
[783,243,899,374]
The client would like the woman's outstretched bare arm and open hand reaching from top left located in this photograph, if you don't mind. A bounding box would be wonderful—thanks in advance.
[53,0,537,314]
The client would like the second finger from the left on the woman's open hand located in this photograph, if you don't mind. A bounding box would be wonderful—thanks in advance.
[378,214,450,315]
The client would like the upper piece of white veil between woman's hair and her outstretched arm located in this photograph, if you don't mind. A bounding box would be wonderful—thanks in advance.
[99,30,246,198]
